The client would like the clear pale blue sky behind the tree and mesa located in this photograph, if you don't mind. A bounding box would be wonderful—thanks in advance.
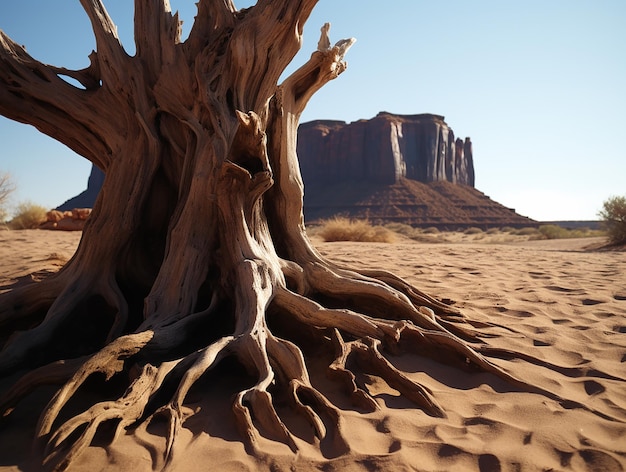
[0,0,626,221]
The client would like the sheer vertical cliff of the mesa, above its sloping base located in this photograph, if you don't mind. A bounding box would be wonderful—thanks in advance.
[298,112,474,187]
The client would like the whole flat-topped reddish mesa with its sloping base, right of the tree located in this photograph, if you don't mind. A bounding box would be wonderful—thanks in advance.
[298,112,534,229]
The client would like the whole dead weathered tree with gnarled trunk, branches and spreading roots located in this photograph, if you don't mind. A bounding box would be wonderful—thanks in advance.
[0,0,608,470]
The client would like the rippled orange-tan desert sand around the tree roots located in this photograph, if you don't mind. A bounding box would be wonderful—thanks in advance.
[0,230,626,472]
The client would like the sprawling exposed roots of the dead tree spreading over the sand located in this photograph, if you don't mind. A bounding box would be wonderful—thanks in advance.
[1,249,622,470]
